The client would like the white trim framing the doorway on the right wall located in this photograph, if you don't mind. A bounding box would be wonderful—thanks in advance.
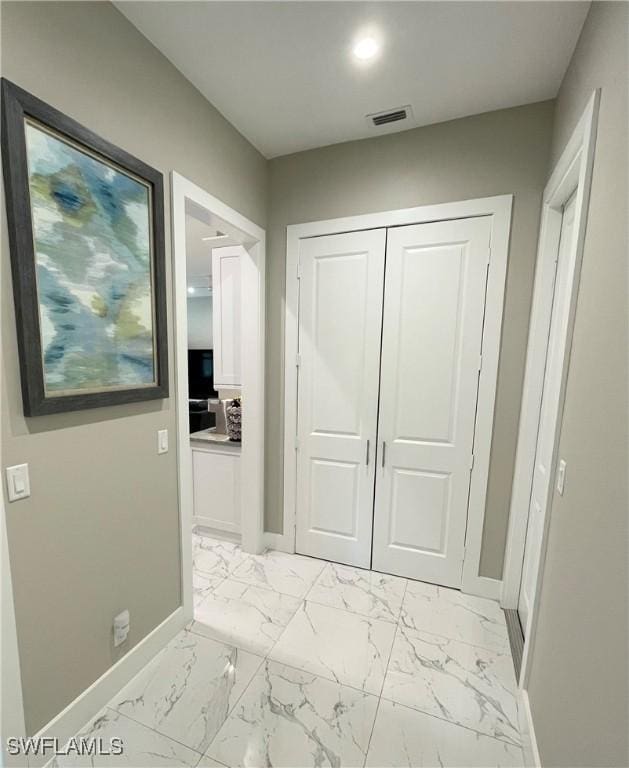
[502,90,600,688]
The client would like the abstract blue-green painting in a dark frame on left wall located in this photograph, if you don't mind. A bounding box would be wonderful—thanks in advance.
[2,79,168,416]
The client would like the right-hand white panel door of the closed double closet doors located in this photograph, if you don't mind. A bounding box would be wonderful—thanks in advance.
[373,217,491,587]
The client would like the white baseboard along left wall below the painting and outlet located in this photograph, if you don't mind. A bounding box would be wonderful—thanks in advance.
[29,607,186,768]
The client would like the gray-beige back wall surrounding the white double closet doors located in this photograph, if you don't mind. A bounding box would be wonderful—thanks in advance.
[265,102,553,578]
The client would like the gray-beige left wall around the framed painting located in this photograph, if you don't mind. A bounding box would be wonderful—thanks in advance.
[1,2,266,733]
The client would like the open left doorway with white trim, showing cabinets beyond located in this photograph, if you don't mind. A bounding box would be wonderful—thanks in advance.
[171,172,265,620]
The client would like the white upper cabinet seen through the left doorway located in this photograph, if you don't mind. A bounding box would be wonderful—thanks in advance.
[212,245,244,389]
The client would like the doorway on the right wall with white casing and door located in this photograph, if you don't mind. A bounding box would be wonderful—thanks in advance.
[502,91,600,697]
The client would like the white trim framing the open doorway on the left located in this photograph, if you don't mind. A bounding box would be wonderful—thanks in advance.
[171,171,266,619]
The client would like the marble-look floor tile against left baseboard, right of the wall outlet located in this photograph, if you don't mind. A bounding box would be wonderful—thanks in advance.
[109,631,262,752]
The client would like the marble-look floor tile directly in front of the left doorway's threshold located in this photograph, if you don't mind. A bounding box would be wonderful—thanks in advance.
[192,579,300,656]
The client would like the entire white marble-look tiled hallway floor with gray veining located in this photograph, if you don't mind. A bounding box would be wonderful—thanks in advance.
[52,544,523,768]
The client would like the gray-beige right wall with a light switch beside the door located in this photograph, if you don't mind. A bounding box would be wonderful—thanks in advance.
[529,2,629,767]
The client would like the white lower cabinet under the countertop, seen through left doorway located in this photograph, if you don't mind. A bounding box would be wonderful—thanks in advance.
[192,443,241,533]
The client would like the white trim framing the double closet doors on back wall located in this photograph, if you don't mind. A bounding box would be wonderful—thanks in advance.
[282,195,513,599]
